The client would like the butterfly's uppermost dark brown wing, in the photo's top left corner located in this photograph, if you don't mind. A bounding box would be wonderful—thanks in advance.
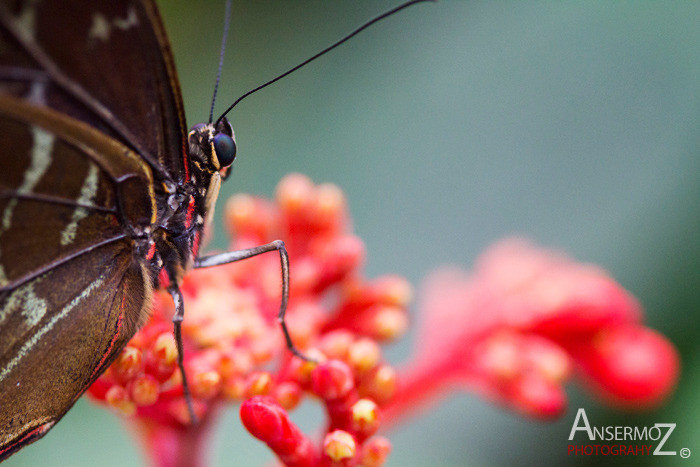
[0,0,187,180]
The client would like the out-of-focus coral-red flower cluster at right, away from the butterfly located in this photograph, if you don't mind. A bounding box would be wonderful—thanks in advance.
[385,239,679,419]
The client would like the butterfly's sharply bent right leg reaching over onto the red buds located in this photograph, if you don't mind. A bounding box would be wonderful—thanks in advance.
[194,240,314,361]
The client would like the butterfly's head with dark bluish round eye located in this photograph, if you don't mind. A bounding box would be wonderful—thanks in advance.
[187,118,236,180]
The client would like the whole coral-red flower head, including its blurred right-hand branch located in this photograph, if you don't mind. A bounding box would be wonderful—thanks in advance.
[90,175,679,467]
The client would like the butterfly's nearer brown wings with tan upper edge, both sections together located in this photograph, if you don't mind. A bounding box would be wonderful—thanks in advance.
[0,94,156,458]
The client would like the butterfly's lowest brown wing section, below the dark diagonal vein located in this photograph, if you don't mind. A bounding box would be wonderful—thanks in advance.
[0,238,150,460]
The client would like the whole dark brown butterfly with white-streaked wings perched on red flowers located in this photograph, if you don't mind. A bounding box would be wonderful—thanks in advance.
[0,0,425,460]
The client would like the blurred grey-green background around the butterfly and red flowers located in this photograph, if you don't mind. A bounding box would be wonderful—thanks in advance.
[6,0,700,467]
